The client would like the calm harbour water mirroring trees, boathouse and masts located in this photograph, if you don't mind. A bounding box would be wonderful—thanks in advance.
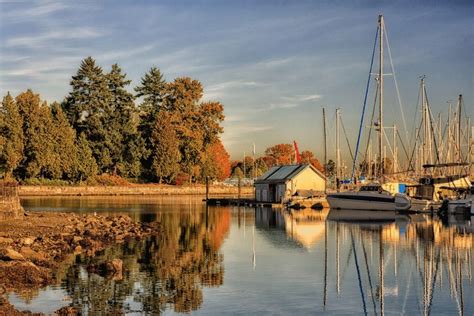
[9,197,474,315]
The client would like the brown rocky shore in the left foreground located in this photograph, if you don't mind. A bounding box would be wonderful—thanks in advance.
[0,212,159,315]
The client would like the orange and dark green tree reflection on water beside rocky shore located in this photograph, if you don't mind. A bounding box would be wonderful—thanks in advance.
[60,210,230,314]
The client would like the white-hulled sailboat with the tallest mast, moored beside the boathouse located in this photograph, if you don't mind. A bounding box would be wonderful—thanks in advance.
[326,15,411,211]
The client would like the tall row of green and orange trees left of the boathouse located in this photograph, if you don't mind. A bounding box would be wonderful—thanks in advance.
[0,57,230,183]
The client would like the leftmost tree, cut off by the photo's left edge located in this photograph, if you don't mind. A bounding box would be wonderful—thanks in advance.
[0,93,24,178]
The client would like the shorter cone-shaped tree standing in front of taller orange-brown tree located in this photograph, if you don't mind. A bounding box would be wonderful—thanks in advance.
[151,111,181,183]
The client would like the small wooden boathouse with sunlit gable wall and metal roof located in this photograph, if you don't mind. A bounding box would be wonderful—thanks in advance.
[254,164,325,203]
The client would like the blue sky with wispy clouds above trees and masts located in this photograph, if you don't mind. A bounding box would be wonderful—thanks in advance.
[0,0,474,160]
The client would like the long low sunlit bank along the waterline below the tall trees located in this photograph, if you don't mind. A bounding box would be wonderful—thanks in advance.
[18,184,253,196]
